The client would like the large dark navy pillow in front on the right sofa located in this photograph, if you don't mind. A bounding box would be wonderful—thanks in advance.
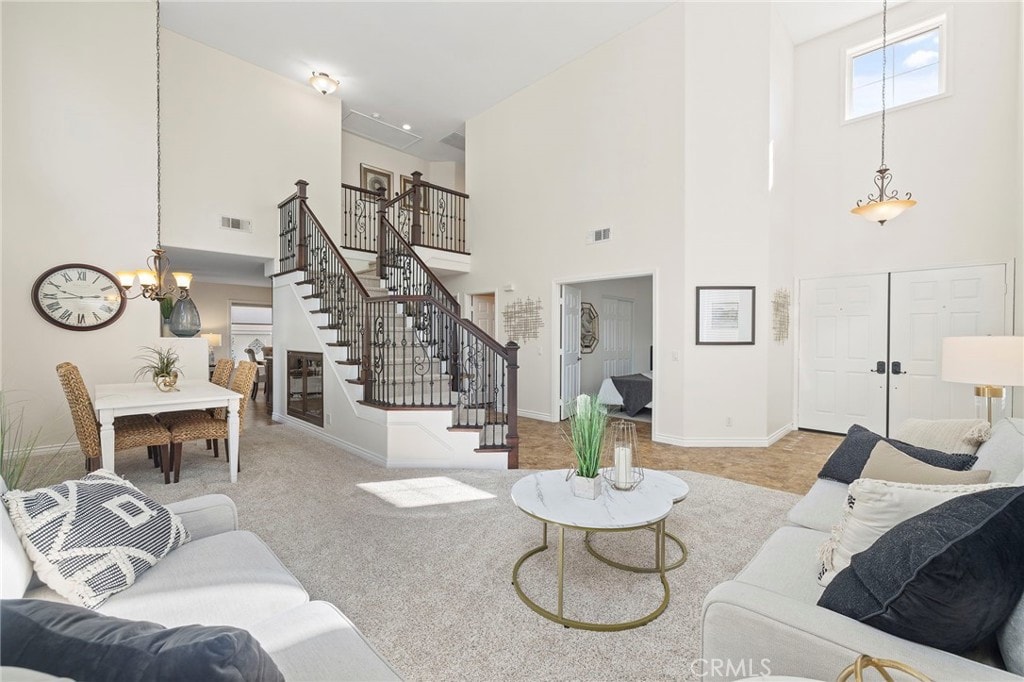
[818,486,1024,653]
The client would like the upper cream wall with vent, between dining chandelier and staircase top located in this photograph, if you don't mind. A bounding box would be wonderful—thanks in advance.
[160,31,342,258]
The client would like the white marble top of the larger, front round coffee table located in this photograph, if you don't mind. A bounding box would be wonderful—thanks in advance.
[512,469,678,530]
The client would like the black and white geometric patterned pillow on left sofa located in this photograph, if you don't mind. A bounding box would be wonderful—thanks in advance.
[3,469,188,608]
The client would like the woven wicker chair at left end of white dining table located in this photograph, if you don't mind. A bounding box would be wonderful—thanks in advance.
[57,363,171,483]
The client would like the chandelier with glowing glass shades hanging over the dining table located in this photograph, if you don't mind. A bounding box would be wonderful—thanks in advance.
[117,0,200,336]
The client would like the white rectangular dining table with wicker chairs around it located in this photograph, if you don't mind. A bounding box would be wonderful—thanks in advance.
[92,380,241,483]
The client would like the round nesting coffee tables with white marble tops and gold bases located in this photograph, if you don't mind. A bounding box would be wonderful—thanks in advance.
[512,469,689,631]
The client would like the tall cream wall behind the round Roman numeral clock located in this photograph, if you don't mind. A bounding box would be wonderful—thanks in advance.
[0,2,160,444]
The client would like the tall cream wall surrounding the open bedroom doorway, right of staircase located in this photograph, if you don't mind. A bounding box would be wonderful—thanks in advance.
[458,5,686,436]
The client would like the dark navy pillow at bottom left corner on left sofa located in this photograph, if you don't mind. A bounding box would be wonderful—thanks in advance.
[0,599,284,682]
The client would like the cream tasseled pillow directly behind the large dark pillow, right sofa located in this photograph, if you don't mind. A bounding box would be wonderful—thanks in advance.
[818,478,1007,586]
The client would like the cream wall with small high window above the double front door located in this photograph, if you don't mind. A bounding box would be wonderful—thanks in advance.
[795,2,1022,278]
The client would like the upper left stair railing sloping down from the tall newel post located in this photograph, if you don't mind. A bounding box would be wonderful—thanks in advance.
[279,180,370,378]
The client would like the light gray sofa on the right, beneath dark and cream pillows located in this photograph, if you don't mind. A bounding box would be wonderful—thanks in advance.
[701,419,1024,682]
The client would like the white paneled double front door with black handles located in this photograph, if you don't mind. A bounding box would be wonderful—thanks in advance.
[798,264,1012,433]
